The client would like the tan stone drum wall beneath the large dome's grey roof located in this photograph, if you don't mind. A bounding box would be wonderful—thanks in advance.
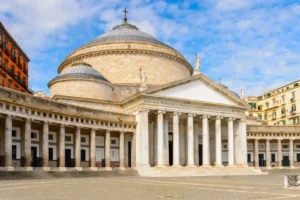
[59,43,192,85]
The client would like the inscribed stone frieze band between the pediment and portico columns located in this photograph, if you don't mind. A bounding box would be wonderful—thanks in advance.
[145,99,241,112]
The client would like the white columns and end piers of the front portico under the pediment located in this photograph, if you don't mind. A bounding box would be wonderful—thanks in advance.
[137,109,247,167]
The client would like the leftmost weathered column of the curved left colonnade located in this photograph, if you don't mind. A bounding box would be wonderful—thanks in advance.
[4,115,14,171]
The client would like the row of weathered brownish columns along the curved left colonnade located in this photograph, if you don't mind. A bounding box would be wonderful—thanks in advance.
[0,115,135,171]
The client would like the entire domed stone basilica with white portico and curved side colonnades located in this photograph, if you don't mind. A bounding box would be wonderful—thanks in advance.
[0,15,300,176]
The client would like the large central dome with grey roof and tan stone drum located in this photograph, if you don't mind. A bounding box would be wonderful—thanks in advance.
[58,17,193,87]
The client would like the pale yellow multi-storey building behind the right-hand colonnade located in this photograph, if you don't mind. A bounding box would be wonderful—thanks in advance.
[246,80,300,125]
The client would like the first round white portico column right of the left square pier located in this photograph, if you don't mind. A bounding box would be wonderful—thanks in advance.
[157,110,166,167]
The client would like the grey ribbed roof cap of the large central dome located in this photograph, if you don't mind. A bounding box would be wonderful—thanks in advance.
[83,21,173,49]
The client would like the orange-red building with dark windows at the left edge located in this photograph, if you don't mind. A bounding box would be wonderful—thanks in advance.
[0,22,31,93]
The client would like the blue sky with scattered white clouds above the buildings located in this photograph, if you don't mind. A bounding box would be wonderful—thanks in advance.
[0,0,300,96]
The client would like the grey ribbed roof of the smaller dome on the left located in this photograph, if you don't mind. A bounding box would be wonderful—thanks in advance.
[48,62,110,85]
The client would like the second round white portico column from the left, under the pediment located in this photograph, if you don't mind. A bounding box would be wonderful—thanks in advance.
[173,112,181,167]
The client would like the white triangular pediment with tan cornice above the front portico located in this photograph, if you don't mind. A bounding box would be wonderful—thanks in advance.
[146,75,246,107]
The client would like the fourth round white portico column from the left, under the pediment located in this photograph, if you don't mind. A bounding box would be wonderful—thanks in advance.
[202,115,211,167]
